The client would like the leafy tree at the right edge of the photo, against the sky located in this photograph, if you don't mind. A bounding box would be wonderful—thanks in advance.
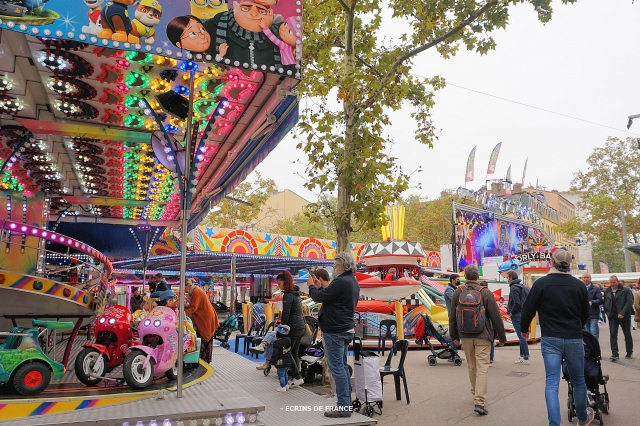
[571,137,640,272]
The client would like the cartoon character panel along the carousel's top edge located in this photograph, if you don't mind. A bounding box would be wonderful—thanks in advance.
[0,0,302,78]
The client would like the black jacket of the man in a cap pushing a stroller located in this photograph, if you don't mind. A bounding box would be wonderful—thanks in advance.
[520,269,589,339]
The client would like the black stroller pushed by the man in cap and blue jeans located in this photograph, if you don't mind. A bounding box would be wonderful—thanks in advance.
[562,330,609,425]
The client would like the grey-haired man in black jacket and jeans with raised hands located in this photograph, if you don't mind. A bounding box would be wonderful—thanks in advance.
[309,252,360,417]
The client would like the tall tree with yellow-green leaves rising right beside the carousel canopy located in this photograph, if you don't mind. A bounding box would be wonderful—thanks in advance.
[298,0,575,251]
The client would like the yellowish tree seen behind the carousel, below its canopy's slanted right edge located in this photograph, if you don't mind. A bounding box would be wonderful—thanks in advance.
[200,172,276,229]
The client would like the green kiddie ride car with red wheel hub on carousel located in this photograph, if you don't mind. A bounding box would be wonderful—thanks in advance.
[0,319,73,396]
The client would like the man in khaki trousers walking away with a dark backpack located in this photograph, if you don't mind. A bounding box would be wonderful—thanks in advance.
[449,265,507,415]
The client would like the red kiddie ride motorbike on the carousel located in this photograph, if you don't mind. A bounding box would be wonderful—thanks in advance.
[75,305,134,386]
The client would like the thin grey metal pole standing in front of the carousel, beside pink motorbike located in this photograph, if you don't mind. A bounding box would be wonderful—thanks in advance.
[176,68,196,398]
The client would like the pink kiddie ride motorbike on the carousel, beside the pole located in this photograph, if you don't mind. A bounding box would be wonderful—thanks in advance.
[122,306,200,389]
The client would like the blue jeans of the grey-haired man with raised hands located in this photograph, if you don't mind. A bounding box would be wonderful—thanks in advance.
[322,333,354,410]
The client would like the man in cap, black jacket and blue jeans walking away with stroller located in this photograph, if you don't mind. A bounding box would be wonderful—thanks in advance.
[520,249,595,426]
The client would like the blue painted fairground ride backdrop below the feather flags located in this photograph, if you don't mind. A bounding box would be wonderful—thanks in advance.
[455,208,541,268]
